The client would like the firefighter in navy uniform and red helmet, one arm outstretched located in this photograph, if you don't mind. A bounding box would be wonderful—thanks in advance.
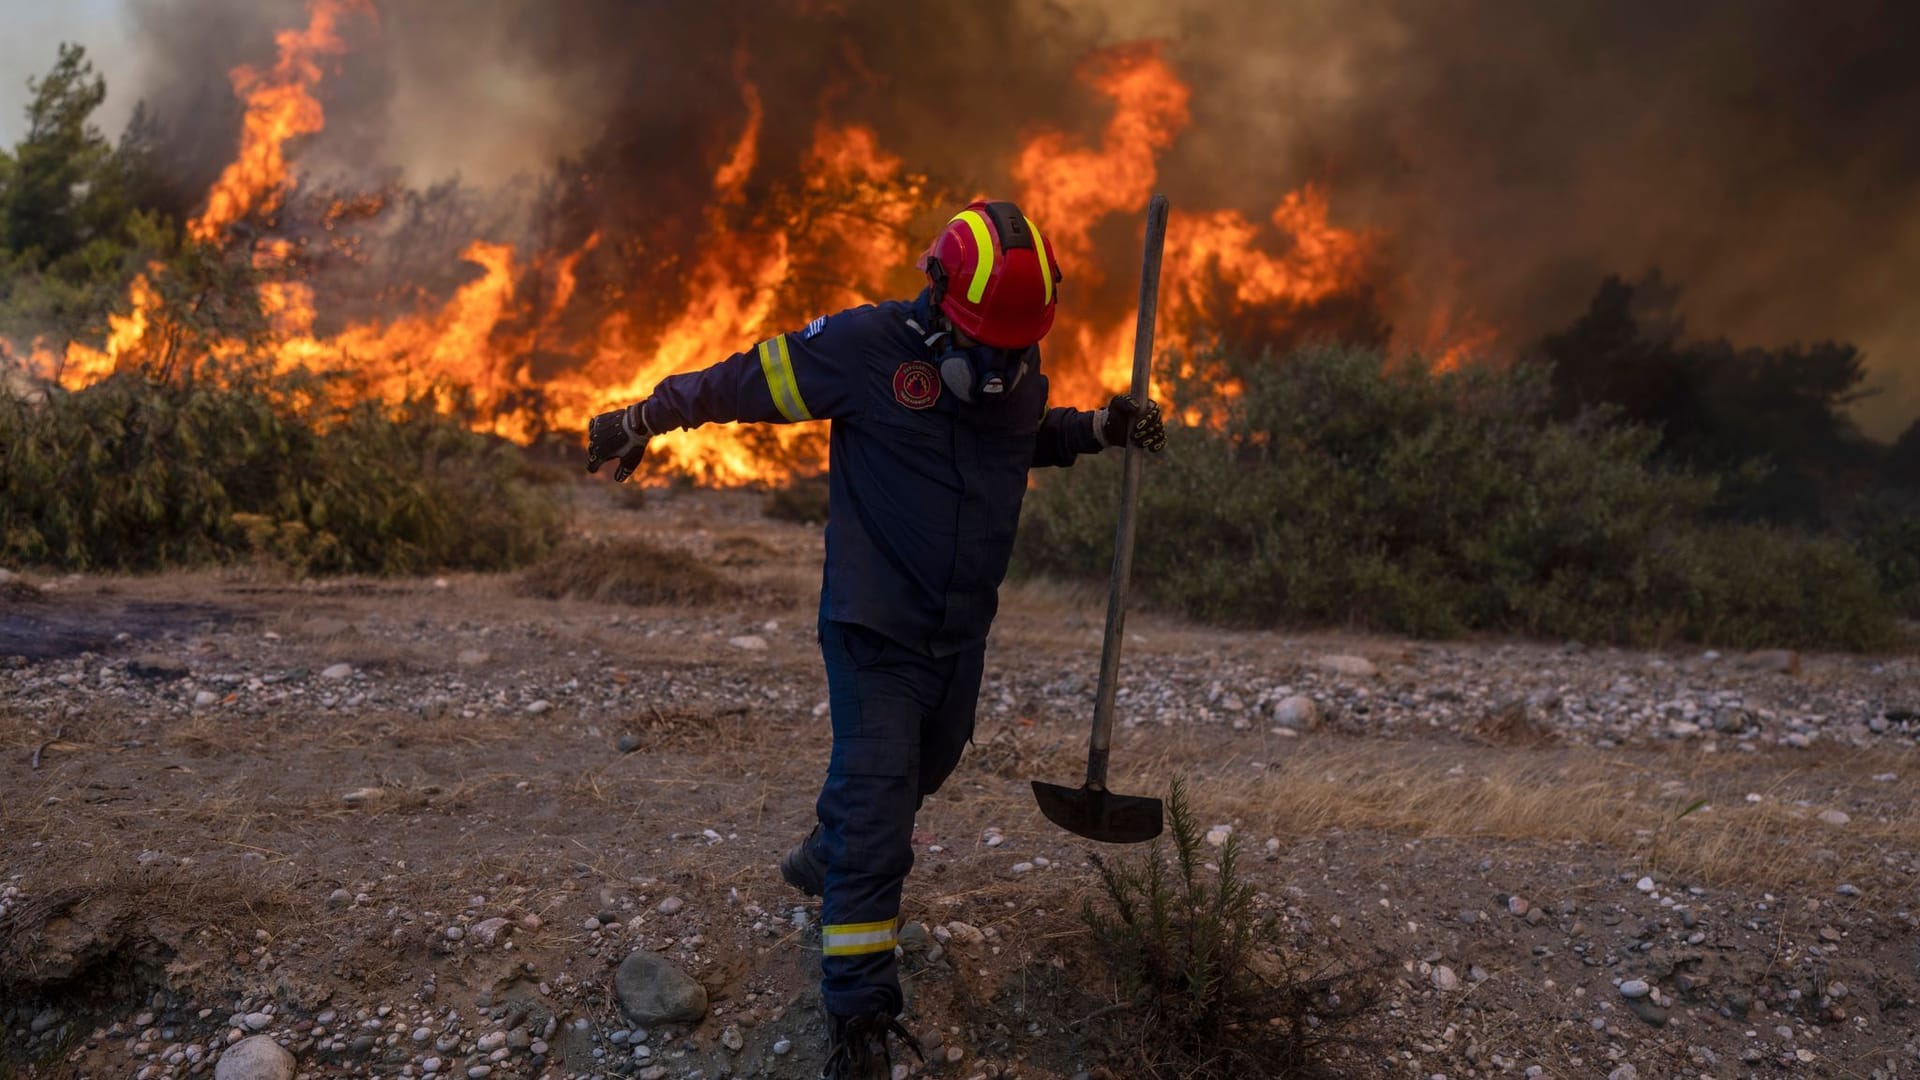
[588,202,1165,1080]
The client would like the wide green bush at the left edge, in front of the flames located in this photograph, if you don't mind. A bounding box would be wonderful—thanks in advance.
[0,363,563,573]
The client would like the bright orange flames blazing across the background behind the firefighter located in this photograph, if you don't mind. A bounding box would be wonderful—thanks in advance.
[0,0,1490,484]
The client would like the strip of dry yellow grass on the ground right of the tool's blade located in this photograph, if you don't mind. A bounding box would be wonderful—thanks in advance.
[1158,744,1920,888]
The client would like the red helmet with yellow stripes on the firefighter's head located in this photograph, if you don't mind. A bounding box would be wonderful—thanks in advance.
[920,200,1060,348]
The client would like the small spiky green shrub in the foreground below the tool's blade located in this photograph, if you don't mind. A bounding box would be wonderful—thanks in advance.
[1083,778,1377,1080]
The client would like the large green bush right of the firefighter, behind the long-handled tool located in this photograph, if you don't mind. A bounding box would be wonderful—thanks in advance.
[1016,348,1891,648]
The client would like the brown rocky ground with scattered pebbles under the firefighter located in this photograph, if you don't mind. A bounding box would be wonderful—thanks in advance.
[0,488,1920,1080]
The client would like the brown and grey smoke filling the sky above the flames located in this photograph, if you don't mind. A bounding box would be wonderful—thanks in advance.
[116,0,1920,434]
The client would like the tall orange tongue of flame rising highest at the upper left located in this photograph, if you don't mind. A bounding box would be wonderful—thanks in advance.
[186,0,371,244]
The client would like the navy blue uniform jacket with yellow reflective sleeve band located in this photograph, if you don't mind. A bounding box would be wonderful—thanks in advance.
[645,294,1100,657]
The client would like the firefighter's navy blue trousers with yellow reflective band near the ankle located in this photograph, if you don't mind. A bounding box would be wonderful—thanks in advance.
[814,605,987,1017]
